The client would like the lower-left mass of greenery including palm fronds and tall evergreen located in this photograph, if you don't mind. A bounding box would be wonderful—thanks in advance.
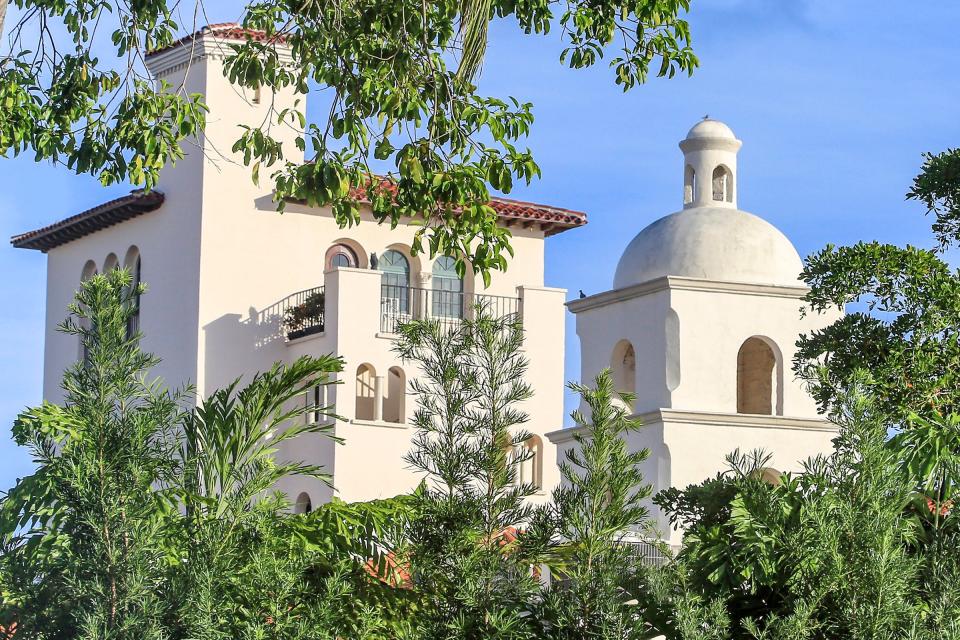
[0,270,411,640]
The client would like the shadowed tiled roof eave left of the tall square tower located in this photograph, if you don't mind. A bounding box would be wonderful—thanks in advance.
[10,190,163,253]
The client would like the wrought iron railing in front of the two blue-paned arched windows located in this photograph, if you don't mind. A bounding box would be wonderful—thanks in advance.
[380,284,520,333]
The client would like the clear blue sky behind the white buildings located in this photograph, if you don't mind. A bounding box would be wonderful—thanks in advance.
[0,0,960,488]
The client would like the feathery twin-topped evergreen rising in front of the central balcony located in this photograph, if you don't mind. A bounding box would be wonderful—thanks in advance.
[397,306,546,640]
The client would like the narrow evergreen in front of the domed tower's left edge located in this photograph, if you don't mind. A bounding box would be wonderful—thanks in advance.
[542,370,651,640]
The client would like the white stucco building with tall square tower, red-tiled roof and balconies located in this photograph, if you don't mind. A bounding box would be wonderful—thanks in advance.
[12,25,586,506]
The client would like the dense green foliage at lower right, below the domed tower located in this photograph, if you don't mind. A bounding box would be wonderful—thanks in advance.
[658,382,960,640]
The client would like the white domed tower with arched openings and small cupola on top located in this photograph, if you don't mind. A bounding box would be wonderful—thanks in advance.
[548,119,839,544]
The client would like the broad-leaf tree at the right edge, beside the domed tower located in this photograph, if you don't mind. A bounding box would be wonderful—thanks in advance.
[795,150,960,528]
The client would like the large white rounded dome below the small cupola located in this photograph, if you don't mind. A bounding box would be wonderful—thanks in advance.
[613,209,803,289]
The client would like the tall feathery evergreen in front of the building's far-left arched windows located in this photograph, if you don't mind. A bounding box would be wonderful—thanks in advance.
[0,271,180,640]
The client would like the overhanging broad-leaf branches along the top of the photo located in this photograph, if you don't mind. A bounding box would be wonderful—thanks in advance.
[0,0,697,278]
